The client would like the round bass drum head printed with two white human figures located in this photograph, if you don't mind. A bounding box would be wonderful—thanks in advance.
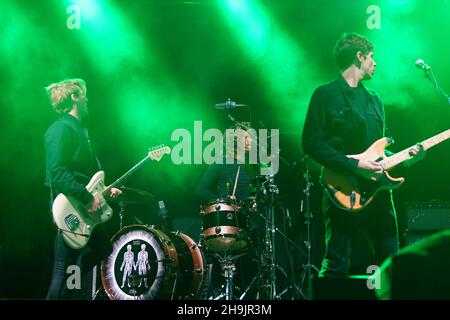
[101,225,176,300]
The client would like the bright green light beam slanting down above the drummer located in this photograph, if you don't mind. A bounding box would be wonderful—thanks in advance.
[220,0,319,131]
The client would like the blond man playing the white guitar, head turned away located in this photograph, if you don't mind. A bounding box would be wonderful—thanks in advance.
[45,79,121,299]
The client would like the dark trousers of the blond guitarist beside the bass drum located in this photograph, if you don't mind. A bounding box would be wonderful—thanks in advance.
[46,227,112,300]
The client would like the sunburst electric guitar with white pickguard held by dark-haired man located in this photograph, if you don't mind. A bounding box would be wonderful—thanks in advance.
[321,129,450,212]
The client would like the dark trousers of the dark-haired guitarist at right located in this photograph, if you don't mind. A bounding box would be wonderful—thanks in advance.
[320,192,399,276]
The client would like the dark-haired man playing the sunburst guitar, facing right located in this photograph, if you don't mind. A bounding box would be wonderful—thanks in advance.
[302,33,424,276]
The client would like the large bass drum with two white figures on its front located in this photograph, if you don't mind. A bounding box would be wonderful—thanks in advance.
[101,225,205,300]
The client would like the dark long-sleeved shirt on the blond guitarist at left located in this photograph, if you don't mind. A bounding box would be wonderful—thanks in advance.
[45,114,100,204]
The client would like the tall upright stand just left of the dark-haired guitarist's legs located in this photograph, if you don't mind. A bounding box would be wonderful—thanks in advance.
[300,158,319,299]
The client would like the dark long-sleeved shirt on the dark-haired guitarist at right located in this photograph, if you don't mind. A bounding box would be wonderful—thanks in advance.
[302,76,384,173]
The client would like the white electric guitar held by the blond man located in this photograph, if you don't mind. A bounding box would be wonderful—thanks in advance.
[52,146,171,249]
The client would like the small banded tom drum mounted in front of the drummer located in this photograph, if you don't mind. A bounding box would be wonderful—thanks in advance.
[201,199,248,252]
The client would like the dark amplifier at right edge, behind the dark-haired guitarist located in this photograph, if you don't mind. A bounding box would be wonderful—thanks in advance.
[405,201,450,232]
